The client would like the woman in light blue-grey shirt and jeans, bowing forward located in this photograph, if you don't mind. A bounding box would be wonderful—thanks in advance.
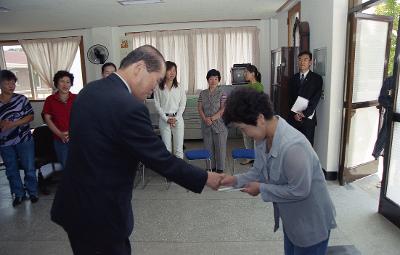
[221,88,336,255]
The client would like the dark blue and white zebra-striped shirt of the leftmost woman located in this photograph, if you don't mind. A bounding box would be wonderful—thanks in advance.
[0,93,33,147]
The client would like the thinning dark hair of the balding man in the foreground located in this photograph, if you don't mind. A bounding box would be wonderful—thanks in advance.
[119,45,165,73]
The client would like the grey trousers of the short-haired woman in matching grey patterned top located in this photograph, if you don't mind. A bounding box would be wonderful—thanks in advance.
[202,127,228,170]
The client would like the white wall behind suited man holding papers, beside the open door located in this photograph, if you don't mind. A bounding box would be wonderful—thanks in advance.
[274,0,347,172]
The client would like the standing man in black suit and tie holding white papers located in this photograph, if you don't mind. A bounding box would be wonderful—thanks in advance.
[288,51,322,145]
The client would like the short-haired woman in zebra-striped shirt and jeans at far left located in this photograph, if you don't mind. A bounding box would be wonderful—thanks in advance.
[0,70,39,207]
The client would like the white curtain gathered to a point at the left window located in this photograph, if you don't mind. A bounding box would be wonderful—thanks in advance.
[19,37,81,89]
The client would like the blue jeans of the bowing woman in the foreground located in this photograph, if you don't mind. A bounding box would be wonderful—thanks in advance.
[283,231,330,255]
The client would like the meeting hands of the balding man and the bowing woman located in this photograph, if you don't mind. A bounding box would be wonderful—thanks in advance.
[206,172,260,196]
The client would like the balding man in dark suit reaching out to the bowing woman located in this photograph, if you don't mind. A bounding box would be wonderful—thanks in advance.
[51,45,223,255]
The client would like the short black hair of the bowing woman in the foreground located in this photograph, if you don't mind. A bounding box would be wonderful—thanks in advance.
[222,88,274,126]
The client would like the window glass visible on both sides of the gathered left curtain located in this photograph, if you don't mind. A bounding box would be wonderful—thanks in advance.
[0,41,83,100]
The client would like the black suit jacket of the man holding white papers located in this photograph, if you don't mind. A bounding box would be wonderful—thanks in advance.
[289,70,322,121]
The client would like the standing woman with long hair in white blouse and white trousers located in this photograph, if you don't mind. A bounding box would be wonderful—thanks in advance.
[154,61,186,158]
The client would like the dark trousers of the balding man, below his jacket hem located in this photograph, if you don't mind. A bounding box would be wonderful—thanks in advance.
[68,234,131,255]
